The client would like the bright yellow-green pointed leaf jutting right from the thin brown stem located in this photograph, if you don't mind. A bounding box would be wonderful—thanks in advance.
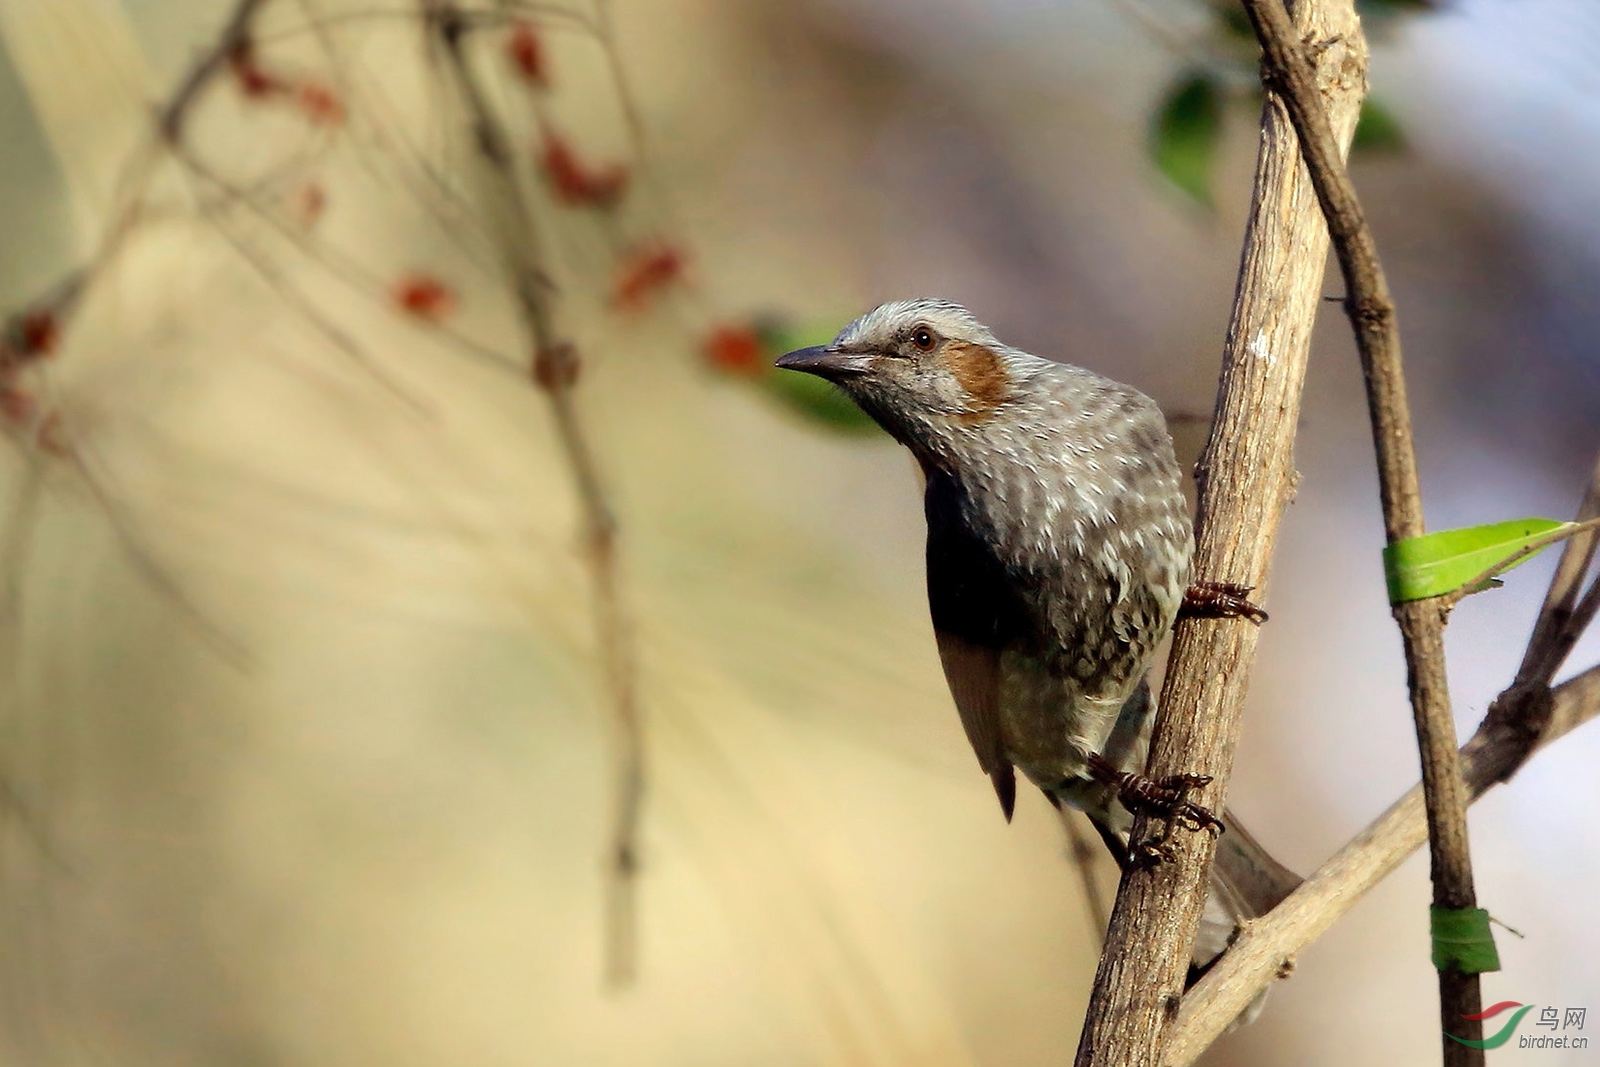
[1384,518,1573,603]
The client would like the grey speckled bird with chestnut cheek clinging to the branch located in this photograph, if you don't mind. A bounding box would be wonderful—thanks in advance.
[776,299,1299,965]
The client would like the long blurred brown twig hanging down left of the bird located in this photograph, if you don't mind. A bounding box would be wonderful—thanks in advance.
[422,0,645,985]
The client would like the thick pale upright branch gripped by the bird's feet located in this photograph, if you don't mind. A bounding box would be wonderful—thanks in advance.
[1077,0,1366,1067]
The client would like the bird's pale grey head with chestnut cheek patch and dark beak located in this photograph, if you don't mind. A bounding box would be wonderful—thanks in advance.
[778,299,1021,454]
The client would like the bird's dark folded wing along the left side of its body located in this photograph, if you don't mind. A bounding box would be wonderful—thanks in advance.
[925,474,1024,821]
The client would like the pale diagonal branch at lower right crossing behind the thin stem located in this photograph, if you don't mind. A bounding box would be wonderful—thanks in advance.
[1165,667,1600,1067]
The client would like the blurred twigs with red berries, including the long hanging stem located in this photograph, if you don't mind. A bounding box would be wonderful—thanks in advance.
[0,0,685,984]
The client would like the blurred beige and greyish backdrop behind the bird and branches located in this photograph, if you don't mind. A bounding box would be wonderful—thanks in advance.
[0,0,1600,1067]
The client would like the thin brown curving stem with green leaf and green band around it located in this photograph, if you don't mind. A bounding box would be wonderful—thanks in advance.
[1243,0,1483,1065]
